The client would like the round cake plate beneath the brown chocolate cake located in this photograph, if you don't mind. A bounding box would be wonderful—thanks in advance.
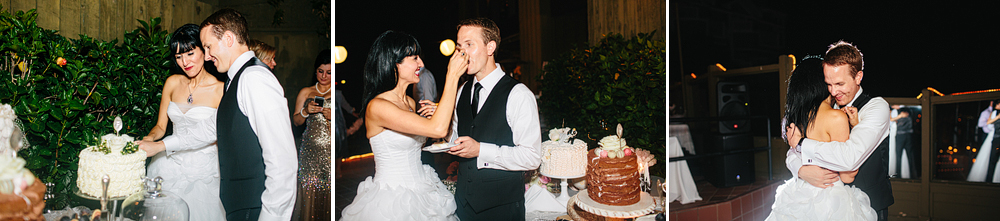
[574,191,653,218]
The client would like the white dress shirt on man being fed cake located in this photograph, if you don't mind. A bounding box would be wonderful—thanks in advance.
[449,64,542,171]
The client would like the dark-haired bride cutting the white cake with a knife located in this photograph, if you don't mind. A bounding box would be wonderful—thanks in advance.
[136,24,226,220]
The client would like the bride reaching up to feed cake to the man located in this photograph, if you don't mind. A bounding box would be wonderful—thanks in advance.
[341,30,468,220]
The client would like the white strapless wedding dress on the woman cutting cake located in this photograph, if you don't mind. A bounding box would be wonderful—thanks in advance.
[146,102,226,221]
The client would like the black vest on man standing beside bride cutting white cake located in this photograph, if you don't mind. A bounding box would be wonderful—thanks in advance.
[216,58,267,213]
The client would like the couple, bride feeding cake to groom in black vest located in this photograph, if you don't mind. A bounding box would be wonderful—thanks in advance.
[342,18,541,220]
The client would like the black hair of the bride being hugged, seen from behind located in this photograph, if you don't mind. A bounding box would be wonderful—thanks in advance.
[783,56,830,138]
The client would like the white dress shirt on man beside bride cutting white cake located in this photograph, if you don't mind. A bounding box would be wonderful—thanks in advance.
[226,51,299,220]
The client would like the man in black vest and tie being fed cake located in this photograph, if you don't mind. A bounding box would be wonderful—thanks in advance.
[448,18,542,220]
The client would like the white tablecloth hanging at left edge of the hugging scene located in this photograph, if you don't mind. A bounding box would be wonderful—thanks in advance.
[667,136,701,204]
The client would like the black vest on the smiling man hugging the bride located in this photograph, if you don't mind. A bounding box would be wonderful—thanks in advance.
[851,93,895,212]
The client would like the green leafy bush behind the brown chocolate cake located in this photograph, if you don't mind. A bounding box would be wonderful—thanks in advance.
[538,33,667,177]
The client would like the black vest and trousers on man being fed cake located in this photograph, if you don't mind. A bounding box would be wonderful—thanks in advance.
[455,75,524,212]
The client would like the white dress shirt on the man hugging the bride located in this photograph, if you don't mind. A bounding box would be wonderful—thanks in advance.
[785,88,889,178]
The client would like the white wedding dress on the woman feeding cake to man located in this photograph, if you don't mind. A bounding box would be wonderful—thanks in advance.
[341,130,458,220]
